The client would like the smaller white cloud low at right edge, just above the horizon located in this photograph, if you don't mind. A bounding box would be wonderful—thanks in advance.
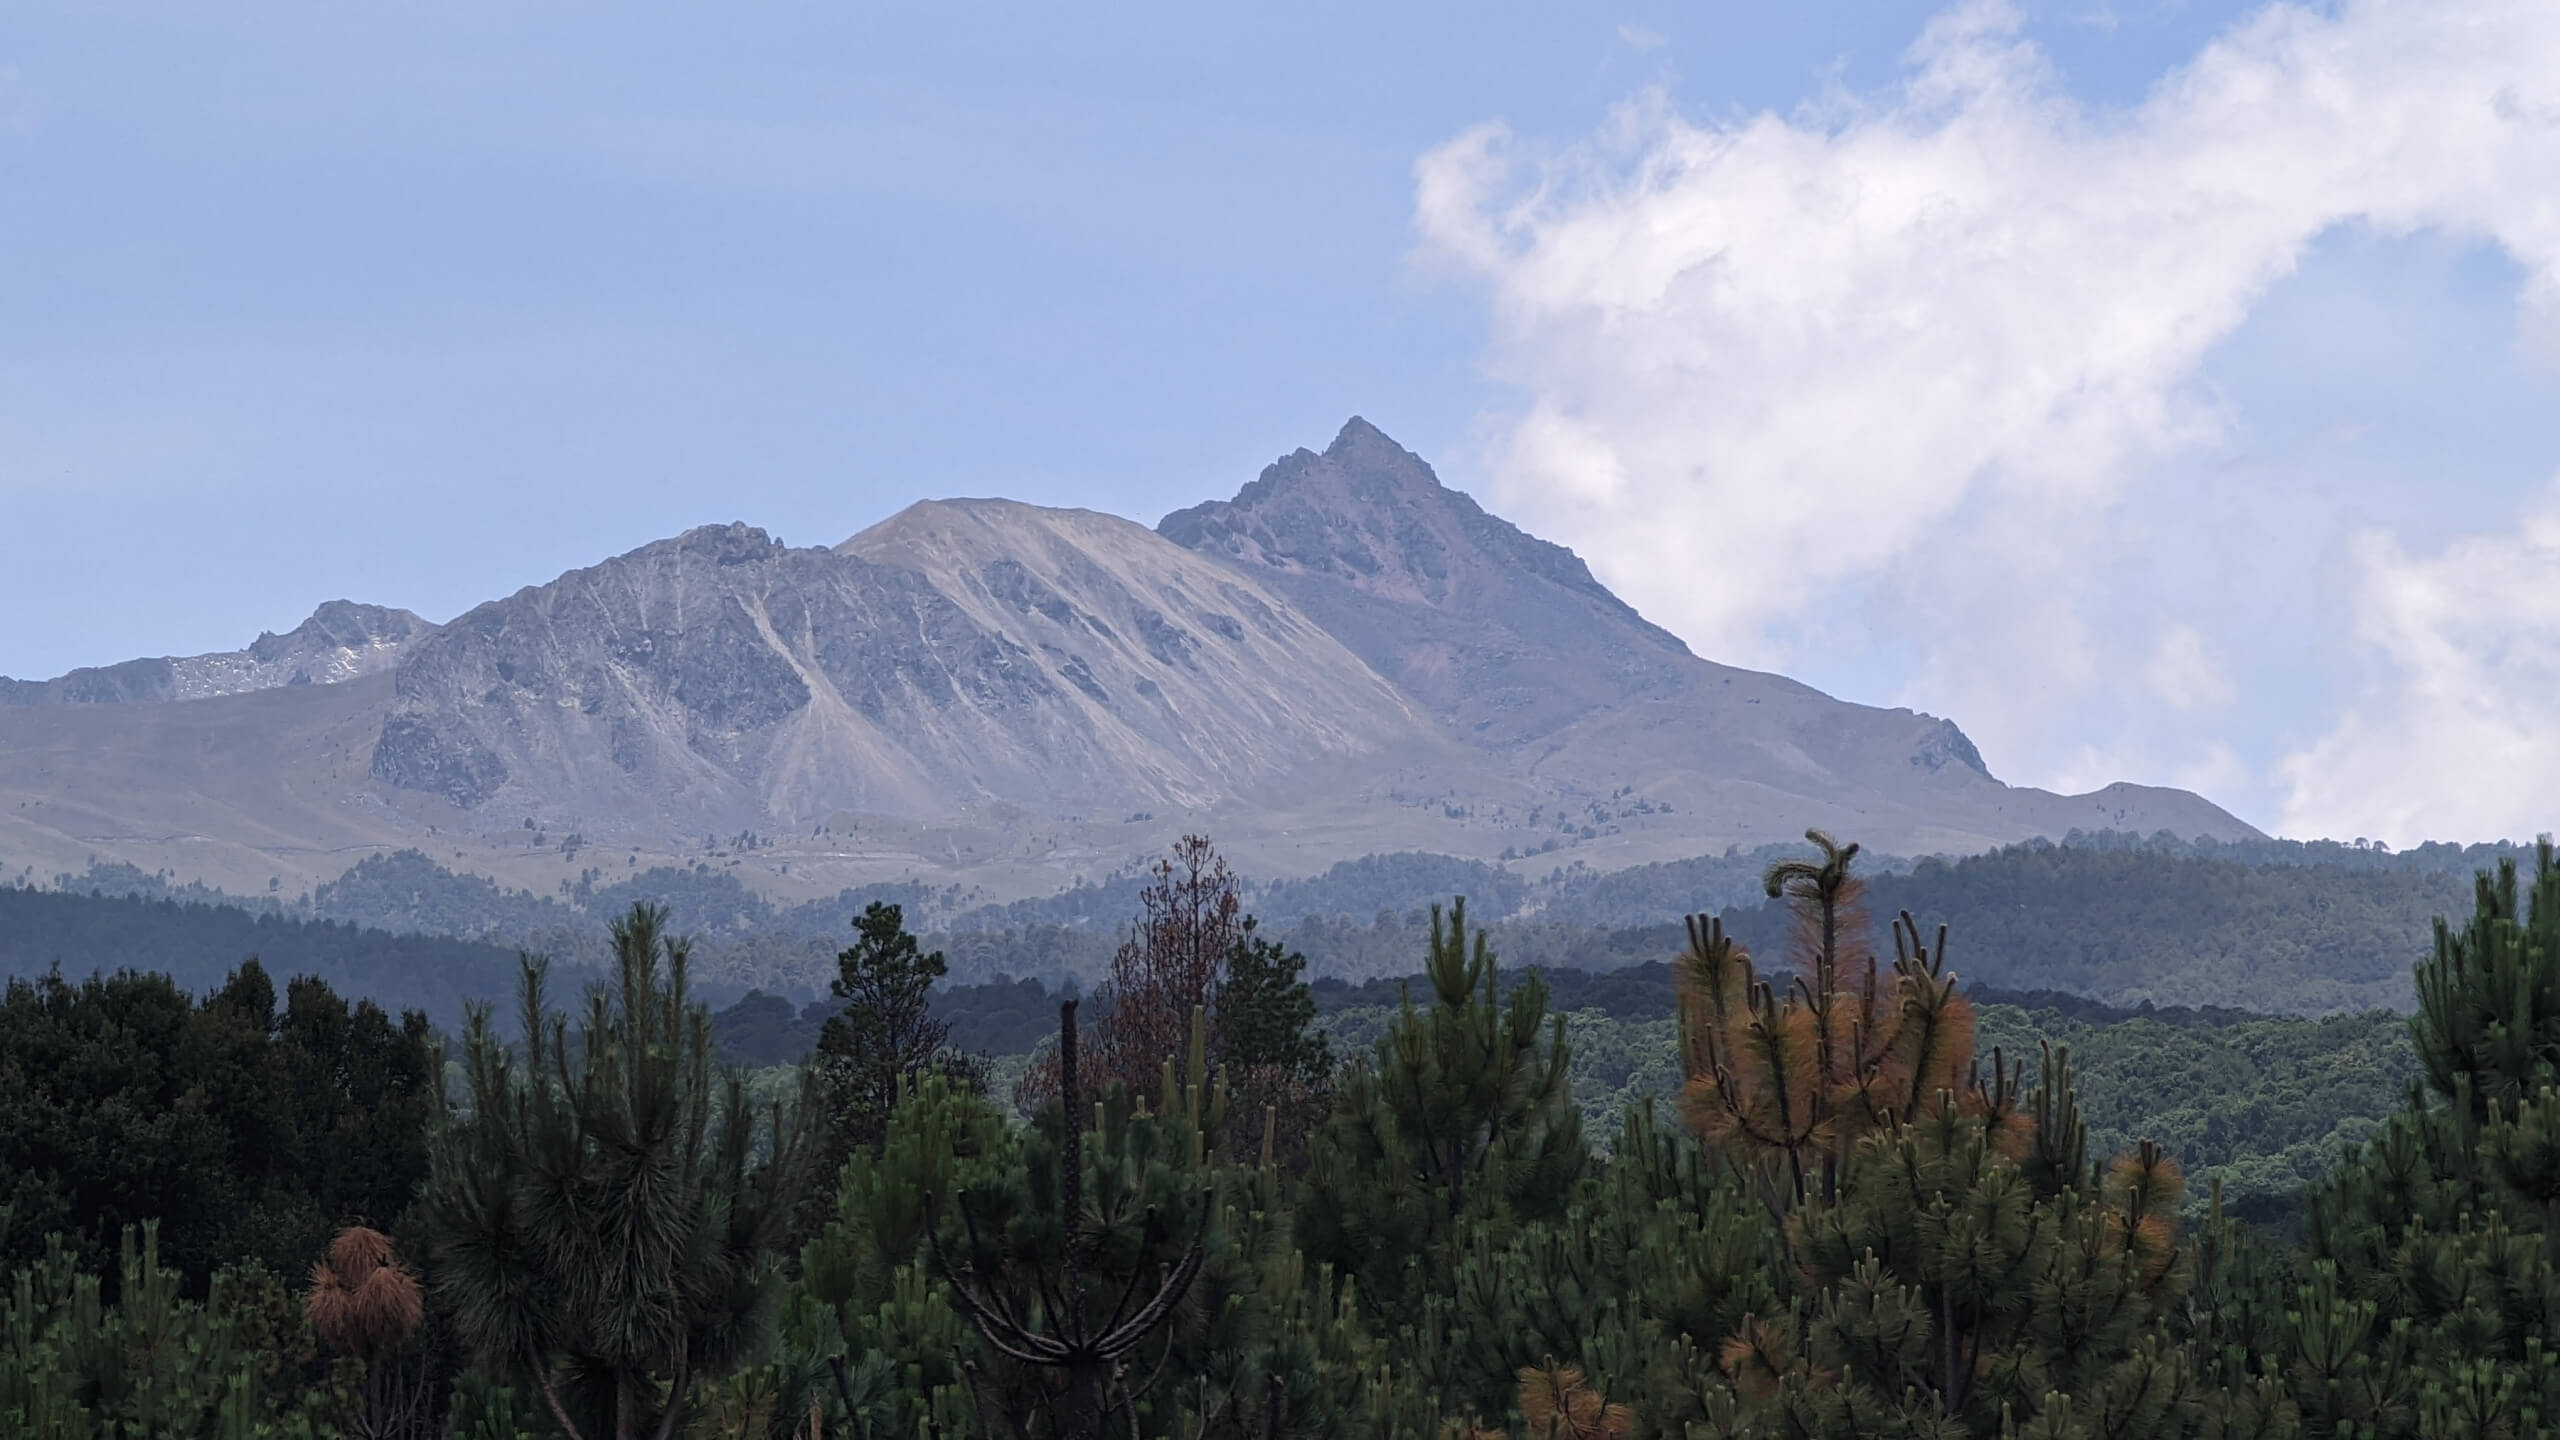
[2284,482,2560,846]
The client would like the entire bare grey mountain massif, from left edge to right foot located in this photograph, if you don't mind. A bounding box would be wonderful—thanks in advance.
[0,420,2253,899]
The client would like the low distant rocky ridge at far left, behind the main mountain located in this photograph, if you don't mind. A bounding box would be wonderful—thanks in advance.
[0,600,435,705]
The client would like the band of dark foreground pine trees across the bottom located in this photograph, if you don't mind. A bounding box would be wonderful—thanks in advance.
[0,838,2560,1440]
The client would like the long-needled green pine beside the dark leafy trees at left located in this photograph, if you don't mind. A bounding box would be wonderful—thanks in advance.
[420,904,817,1440]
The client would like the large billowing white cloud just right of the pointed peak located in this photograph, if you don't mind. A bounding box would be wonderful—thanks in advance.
[1416,0,2560,820]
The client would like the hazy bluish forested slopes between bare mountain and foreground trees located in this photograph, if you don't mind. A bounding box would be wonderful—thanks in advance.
[30,833,2514,1014]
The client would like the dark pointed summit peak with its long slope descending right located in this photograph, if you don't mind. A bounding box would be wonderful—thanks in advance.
[1157,418,2253,853]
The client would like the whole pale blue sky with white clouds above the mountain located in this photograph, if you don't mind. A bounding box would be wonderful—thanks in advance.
[0,0,2560,843]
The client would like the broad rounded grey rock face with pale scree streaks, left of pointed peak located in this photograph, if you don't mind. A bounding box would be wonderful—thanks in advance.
[374,500,1434,822]
